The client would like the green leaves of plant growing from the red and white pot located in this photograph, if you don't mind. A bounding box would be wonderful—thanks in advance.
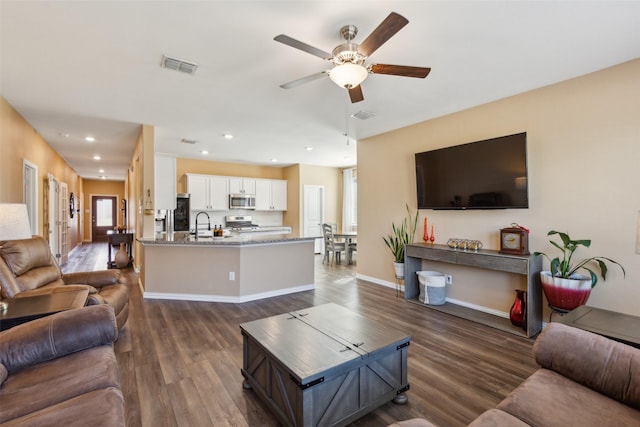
[533,230,626,288]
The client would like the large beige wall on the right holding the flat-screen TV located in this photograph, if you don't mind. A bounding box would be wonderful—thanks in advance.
[357,60,640,315]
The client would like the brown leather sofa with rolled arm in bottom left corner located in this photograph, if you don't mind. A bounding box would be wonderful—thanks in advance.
[0,304,125,427]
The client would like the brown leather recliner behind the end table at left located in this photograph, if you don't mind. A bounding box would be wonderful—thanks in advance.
[0,236,129,329]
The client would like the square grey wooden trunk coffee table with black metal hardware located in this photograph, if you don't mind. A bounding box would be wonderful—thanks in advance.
[240,304,411,427]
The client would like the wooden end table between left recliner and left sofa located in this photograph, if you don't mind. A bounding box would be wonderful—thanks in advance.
[0,289,89,331]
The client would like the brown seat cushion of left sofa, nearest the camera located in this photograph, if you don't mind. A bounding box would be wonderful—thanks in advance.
[3,387,125,427]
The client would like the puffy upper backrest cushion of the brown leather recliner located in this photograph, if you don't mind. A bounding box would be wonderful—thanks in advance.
[0,237,51,276]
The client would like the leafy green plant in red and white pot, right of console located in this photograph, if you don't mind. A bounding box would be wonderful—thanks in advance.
[533,230,626,311]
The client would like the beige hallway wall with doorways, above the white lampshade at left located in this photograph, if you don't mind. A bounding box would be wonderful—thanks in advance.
[0,97,82,249]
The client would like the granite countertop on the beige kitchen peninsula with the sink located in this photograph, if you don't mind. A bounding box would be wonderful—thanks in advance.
[138,233,315,246]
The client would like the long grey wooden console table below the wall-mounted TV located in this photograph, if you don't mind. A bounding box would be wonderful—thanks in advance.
[404,244,542,337]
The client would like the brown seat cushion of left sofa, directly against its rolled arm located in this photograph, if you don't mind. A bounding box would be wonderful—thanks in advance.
[0,345,122,427]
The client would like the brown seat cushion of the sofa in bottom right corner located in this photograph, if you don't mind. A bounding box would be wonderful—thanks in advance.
[497,368,640,427]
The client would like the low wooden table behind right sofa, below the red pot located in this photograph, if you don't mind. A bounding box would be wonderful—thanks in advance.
[559,305,640,348]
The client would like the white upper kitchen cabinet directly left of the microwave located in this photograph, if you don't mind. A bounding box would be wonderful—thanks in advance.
[187,174,229,211]
